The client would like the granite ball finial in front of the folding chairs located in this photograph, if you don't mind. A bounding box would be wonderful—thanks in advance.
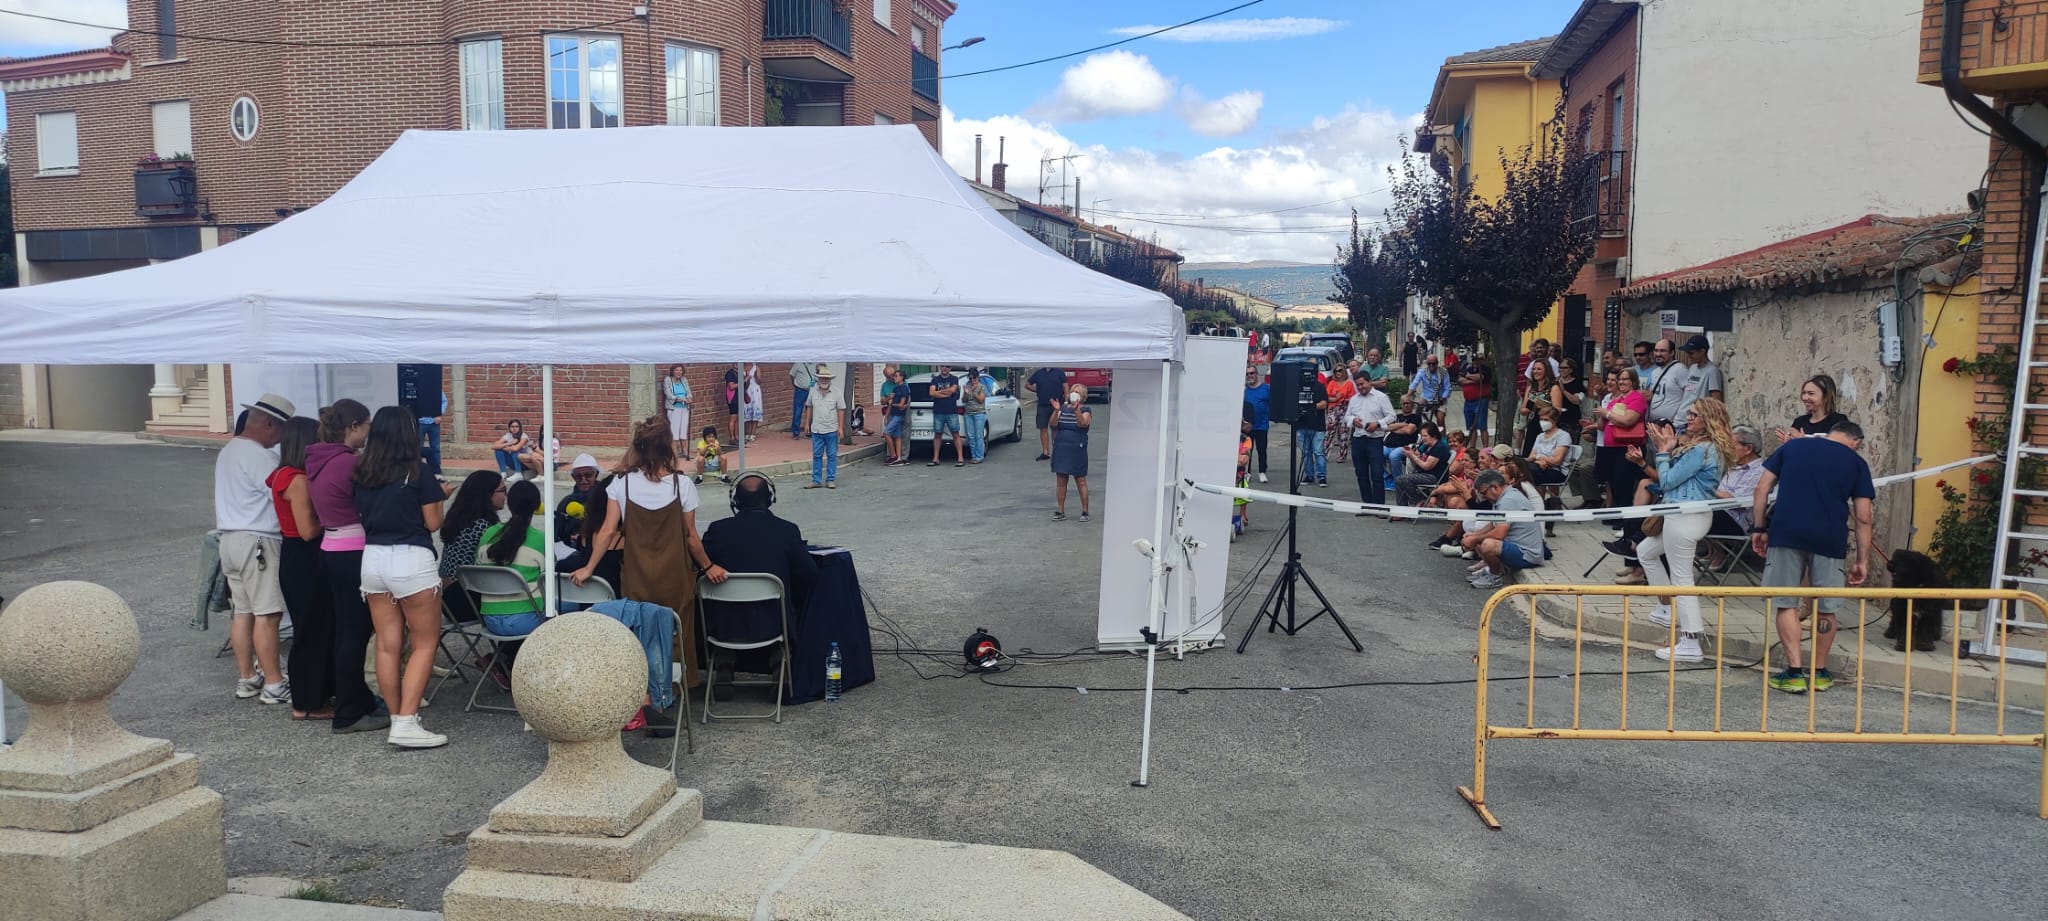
[512,612,647,743]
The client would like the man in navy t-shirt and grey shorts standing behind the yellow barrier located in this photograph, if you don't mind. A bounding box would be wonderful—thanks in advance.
[1749,422,1878,694]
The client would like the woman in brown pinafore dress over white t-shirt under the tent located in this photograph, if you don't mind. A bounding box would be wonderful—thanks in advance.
[569,415,725,731]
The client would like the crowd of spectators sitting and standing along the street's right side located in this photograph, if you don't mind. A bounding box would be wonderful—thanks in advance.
[1233,334,1874,692]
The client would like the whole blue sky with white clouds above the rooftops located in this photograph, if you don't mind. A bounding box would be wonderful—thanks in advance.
[0,0,1579,262]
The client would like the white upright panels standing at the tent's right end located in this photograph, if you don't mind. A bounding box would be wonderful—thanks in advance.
[1096,336,1245,651]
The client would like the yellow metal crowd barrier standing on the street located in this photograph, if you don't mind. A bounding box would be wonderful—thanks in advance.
[1458,585,2048,829]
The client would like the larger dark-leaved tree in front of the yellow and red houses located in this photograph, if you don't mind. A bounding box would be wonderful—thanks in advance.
[1386,113,1602,442]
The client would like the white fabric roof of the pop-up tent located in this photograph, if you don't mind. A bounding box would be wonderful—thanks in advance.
[0,125,1184,366]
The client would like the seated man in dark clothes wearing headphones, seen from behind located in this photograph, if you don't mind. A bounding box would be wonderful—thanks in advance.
[705,471,817,700]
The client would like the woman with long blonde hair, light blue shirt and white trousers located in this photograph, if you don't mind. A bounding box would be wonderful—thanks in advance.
[1636,397,1735,661]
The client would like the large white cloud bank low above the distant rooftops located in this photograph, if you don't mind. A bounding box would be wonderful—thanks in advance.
[942,100,1419,262]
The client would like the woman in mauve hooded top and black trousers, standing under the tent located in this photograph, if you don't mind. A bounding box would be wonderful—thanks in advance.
[305,397,391,733]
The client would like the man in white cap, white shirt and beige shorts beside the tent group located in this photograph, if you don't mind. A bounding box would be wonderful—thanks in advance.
[213,393,293,704]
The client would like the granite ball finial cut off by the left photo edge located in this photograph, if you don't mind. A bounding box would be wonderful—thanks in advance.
[0,581,141,704]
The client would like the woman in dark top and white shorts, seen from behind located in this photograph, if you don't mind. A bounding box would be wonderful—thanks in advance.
[352,405,449,749]
